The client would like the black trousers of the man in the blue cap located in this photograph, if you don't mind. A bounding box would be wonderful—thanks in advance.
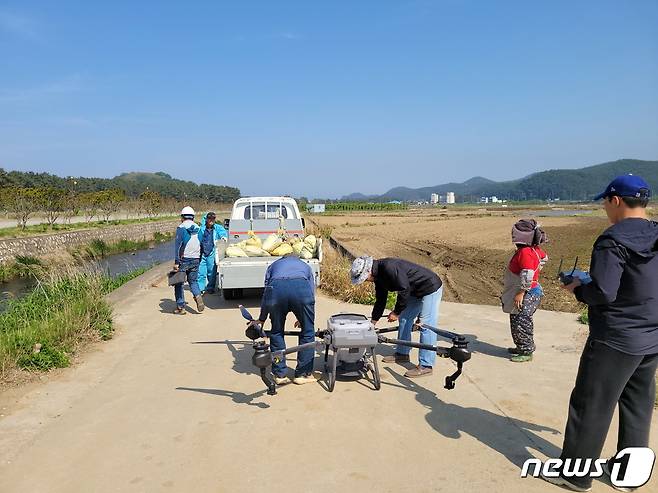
[561,338,658,486]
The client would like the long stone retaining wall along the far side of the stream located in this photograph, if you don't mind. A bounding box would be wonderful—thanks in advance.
[0,220,179,263]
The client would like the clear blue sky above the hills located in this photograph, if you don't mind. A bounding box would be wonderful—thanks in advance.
[0,0,658,197]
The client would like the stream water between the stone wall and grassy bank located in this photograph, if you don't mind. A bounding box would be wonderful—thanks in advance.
[0,241,174,311]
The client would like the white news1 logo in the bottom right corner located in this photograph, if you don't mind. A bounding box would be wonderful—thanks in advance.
[521,447,656,488]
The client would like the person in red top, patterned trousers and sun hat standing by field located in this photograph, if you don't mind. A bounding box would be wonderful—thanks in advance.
[501,219,548,363]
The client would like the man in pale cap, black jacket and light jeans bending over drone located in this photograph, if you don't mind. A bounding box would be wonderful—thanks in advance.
[350,256,443,378]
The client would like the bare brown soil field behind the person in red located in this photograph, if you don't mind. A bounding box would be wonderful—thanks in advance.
[312,209,632,312]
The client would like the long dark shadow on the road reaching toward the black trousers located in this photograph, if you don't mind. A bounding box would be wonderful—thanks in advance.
[382,368,561,468]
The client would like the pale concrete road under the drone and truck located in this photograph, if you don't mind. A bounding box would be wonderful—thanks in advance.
[0,278,658,493]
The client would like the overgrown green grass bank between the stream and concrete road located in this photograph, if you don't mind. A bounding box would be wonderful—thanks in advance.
[0,268,147,381]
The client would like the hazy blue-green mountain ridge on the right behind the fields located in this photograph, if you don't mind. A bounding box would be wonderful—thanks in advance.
[344,159,658,202]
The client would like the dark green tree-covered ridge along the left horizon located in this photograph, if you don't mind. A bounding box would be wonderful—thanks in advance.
[0,168,240,202]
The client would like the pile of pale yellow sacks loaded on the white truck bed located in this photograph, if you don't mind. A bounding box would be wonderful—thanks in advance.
[226,234,318,260]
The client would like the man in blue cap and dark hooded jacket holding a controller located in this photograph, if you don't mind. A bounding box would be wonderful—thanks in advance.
[545,175,658,491]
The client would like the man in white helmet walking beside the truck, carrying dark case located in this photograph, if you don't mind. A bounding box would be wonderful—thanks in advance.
[174,206,205,315]
